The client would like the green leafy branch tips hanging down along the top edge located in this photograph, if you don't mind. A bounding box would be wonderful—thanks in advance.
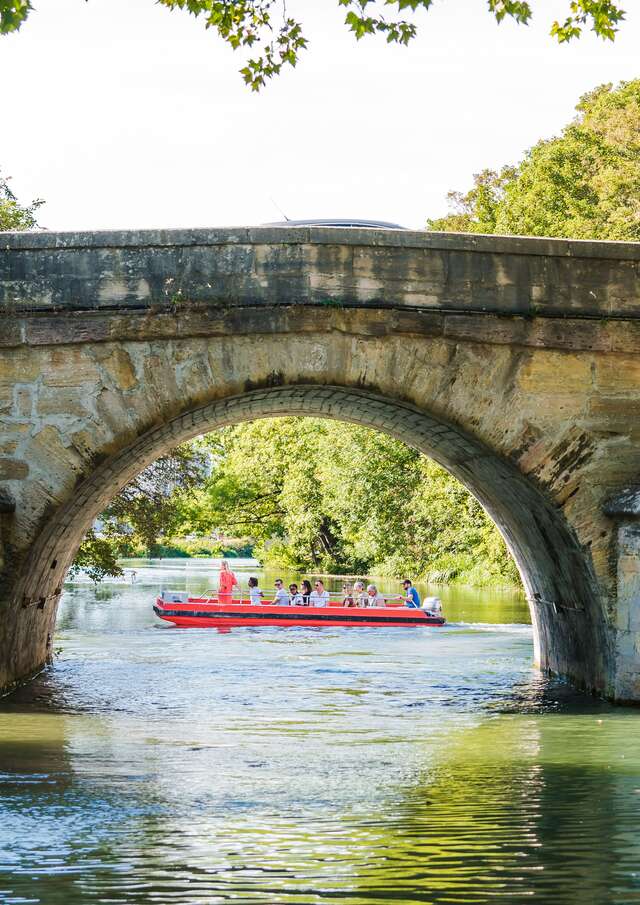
[0,0,625,91]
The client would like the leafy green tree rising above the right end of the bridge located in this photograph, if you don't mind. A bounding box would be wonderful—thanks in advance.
[428,79,640,241]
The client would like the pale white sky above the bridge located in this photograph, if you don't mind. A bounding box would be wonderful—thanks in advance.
[0,0,640,230]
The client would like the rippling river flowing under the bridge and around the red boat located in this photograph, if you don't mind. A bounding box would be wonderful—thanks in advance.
[0,560,640,905]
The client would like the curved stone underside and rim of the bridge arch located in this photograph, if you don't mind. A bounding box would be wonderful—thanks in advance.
[12,384,608,691]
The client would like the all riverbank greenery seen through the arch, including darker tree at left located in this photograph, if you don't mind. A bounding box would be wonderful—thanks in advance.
[72,418,518,585]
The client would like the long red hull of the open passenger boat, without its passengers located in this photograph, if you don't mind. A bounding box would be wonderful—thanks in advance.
[153,591,445,628]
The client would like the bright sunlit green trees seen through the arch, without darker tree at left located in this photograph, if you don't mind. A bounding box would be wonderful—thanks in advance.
[184,418,518,584]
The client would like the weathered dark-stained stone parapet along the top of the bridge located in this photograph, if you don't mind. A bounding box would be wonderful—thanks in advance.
[0,227,640,318]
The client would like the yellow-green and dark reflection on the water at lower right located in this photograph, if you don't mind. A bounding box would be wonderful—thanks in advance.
[348,705,640,905]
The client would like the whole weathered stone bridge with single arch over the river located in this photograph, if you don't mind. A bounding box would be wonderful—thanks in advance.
[0,227,640,701]
